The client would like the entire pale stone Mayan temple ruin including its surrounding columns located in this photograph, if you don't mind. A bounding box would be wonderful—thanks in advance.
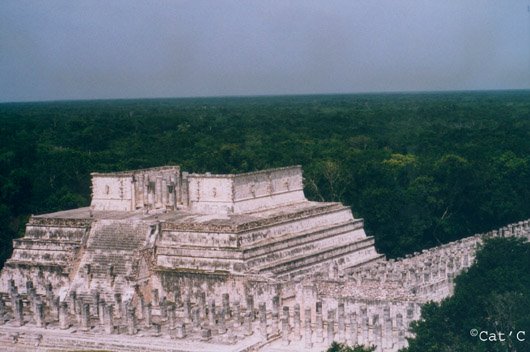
[0,166,530,352]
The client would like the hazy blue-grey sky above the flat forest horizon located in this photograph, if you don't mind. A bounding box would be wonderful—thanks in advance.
[0,0,530,102]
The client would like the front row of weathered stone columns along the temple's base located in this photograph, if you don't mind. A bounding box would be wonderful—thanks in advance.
[0,278,404,345]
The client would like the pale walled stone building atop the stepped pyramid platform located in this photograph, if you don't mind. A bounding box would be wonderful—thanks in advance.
[91,166,305,214]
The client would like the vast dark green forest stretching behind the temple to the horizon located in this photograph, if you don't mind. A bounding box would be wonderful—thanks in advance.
[0,91,530,264]
